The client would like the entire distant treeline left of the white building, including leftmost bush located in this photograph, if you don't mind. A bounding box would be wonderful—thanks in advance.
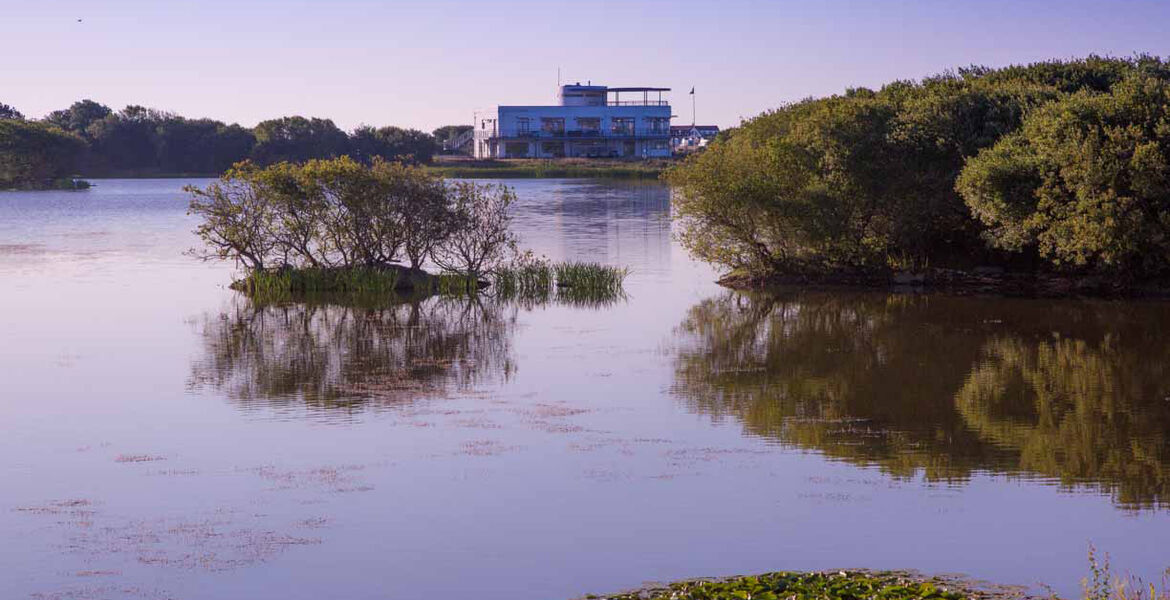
[0,99,466,187]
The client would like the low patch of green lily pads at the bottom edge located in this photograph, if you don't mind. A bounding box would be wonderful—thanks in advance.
[605,571,970,600]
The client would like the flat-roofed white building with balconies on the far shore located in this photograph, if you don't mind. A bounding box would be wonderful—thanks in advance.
[474,83,670,158]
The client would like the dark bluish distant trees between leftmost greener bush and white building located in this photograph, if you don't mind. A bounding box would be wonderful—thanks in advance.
[0,99,436,177]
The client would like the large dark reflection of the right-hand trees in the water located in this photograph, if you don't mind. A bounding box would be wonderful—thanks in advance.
[675,292,1170,508]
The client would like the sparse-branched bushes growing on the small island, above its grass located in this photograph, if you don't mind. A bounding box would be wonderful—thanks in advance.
[186,157,515,276]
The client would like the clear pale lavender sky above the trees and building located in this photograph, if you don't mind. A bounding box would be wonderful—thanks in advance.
[0,0,1170,130]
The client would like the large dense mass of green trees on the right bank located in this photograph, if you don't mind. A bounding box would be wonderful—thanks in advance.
[667,55,1170,281]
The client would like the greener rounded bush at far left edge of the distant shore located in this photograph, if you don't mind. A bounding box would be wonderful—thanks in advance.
[0,119,85,189]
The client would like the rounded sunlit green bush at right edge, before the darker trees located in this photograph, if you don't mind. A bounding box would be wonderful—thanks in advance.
[957,74,1170,277]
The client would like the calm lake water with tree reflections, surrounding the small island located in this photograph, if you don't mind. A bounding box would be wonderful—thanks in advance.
[0,180,1170,600]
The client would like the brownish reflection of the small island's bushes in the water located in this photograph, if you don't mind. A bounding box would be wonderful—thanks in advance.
[191,295,516,413]
